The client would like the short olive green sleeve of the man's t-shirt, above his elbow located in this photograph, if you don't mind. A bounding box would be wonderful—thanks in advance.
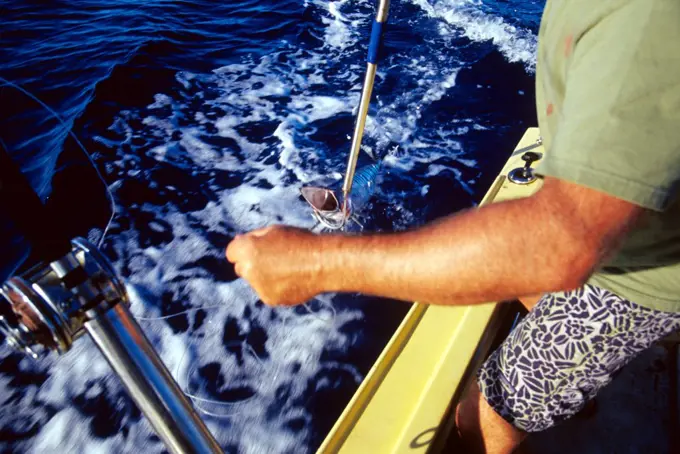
[537,0,680,211]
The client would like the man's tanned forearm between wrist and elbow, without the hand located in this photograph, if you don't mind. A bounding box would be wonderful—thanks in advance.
[320,192,598,304]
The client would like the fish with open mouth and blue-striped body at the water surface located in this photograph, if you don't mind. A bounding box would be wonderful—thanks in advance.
[301,163,380,230]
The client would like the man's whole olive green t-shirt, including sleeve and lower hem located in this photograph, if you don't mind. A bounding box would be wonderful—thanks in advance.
[536,0,680,312]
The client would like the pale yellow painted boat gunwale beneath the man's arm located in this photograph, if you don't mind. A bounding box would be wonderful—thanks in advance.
[318,128,545,454]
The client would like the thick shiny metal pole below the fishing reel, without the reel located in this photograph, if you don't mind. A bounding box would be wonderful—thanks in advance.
[84,304,222,454]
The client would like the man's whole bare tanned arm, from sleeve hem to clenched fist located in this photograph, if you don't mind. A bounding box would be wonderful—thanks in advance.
[227,178,643,305]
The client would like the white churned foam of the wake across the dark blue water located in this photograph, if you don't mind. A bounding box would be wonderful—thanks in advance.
[0,0,525,453]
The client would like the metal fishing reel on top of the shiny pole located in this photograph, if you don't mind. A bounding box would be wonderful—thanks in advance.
[0,238,129,358]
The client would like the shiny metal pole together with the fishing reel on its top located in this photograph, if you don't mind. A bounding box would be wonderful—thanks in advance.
[0,239,222,454]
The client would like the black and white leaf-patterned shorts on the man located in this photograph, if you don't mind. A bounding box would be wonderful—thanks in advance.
[477,285,680,432]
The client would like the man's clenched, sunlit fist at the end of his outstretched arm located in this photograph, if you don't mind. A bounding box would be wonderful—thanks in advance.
[226,226,323,306]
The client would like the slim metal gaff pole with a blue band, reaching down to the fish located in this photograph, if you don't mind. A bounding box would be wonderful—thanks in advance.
[342,0,390,204]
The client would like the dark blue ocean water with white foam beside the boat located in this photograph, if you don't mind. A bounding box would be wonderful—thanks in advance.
[0,0,544,453]
